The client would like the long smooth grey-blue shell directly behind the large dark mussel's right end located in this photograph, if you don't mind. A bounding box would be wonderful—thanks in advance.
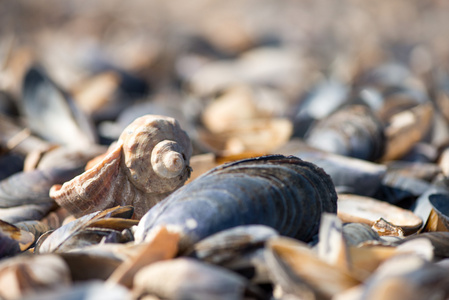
[275,139,387,197]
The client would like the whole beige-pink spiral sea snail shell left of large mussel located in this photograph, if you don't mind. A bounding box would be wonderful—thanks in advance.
[50,115,192,219]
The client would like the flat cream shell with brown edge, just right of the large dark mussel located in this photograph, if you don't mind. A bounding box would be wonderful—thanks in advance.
[337,194,423,234]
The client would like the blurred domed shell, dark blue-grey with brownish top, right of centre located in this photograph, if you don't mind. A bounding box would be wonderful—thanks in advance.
[305,105,385,161]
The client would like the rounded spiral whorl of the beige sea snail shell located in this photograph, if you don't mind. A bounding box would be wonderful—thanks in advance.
[119,115,192,193]
